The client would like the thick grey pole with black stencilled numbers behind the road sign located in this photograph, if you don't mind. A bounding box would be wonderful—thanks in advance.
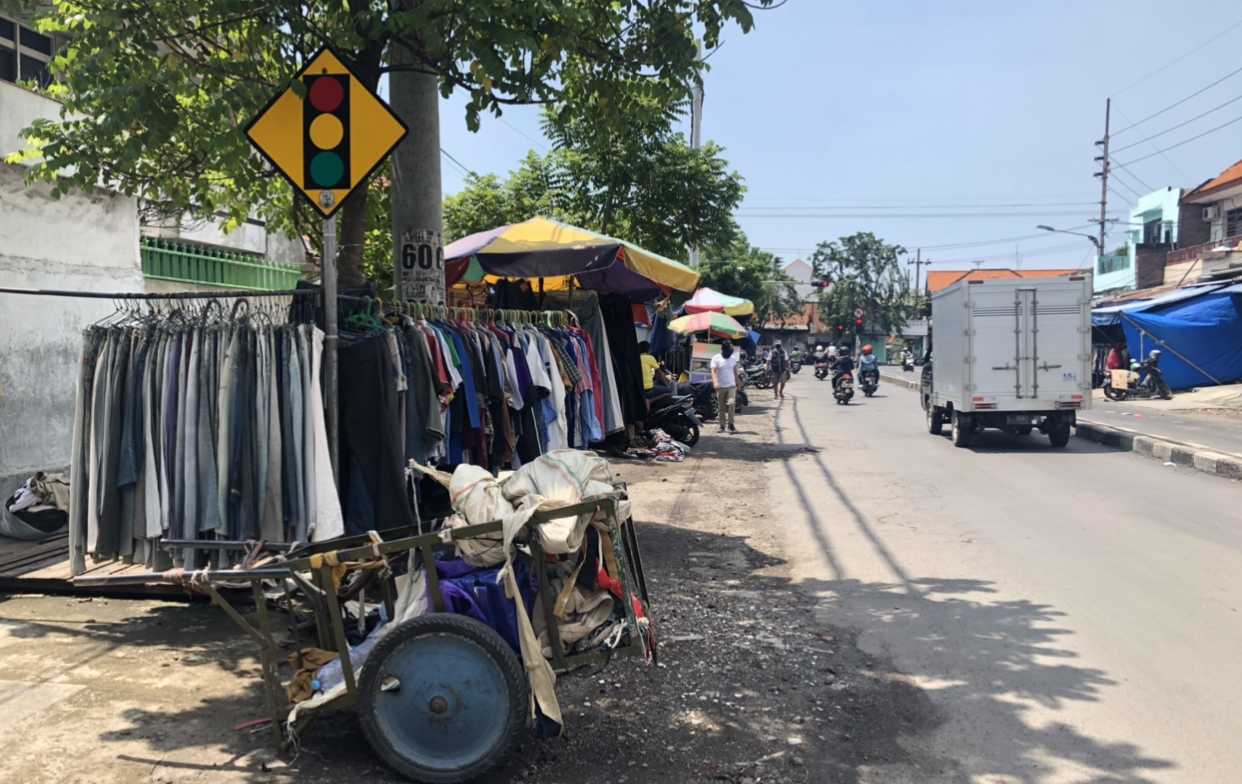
[389,45,446,304]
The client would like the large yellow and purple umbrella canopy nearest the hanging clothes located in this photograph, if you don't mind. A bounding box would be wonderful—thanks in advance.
[445,216,699,302]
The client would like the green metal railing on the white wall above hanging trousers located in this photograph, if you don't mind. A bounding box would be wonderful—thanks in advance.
[142,237,302,291]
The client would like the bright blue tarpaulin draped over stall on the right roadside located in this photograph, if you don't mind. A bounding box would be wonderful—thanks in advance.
[1118,286,1242,389]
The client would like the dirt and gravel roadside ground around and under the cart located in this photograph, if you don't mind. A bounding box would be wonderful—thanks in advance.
[0,393,939,784]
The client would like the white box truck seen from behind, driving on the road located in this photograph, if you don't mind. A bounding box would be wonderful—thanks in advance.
[920,273,1092,447]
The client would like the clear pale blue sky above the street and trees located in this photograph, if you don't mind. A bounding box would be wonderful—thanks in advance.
[441,0,1242,275]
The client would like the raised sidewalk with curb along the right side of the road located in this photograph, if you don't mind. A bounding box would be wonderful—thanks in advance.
[881,368,1242,480]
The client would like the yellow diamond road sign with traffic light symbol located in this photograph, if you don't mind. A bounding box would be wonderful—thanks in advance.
[246,47,409,217]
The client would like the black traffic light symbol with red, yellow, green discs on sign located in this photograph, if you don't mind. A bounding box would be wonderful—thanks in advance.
[302,73,353,190]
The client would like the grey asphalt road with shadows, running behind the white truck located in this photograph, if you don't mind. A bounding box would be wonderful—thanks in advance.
[764,376,1242,784]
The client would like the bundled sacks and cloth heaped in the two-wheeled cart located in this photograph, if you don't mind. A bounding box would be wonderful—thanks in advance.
[287,449,635,734]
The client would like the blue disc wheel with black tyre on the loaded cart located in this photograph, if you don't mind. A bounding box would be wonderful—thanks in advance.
[358,614,528,784]
